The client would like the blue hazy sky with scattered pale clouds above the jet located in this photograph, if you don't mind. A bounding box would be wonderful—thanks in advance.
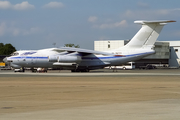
[0,0,180,50]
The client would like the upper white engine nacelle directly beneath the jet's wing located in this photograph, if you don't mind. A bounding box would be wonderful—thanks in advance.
[48,55,82,63]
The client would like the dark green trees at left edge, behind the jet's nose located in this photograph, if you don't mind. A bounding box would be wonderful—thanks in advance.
[0,43,16,55]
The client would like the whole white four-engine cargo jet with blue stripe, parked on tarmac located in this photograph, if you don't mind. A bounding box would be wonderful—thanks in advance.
[4,20,176,72]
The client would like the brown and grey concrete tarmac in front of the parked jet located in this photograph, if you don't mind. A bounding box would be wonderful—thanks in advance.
[0,69,180,120]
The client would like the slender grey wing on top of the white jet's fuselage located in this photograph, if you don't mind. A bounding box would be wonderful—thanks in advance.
[54,47,114,55]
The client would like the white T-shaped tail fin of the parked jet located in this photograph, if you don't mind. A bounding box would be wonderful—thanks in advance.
[125,20,176,48]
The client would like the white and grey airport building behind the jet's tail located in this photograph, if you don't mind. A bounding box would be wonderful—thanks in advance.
[94,40,180,68]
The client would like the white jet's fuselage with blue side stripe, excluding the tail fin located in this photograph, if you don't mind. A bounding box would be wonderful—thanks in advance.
[4,49,154,70]
